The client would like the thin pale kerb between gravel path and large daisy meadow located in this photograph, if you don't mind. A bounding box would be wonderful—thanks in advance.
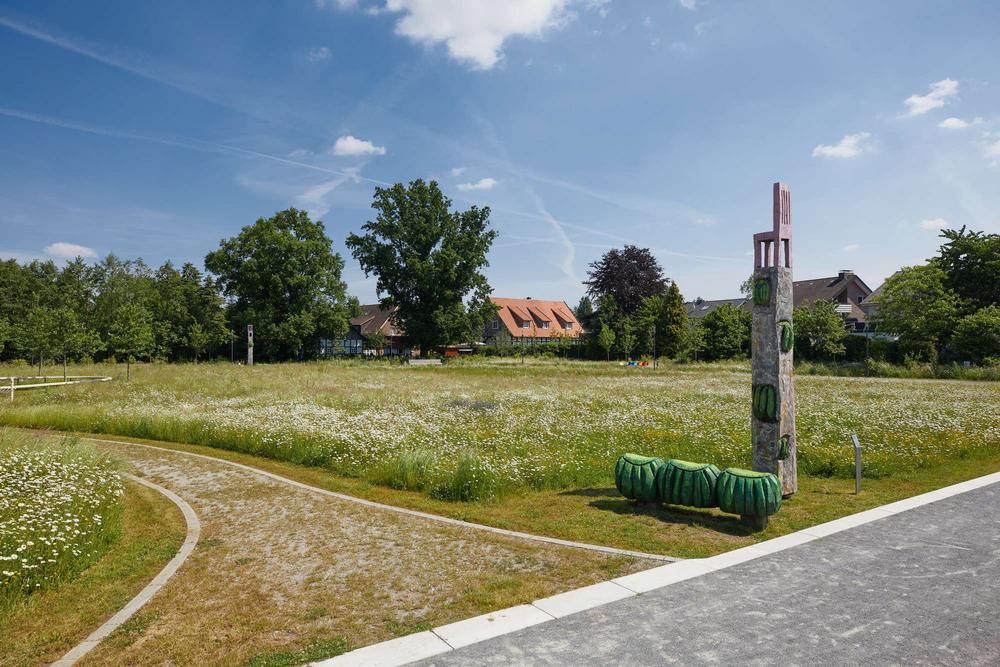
[72,435,681,563]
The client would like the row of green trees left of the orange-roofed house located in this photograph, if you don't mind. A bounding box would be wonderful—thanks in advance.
[0,180,497,373]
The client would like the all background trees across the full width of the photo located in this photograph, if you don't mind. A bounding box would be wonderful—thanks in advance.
[0,179,1000,373]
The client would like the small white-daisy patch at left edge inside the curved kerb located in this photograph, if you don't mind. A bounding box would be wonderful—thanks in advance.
[0,432,124,611]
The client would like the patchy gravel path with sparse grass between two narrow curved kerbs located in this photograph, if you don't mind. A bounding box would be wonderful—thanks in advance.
[81,444,654,665]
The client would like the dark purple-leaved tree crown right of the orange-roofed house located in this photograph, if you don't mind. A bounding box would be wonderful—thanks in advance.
[583,245,667,315]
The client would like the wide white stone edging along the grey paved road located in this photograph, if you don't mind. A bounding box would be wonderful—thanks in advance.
[311,472,1000,667]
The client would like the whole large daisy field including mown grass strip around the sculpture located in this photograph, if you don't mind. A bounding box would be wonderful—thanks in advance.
[0,361,1000,556]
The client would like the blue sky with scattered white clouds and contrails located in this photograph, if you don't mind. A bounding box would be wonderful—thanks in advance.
[0,0,1000,303]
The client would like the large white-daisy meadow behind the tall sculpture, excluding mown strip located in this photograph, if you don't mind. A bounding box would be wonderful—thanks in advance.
[0,361,1000,499]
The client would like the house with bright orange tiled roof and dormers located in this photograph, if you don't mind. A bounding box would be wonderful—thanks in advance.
[483,296,583,343]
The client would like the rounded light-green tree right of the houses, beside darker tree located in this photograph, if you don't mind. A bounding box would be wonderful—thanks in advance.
[877,264,959,361]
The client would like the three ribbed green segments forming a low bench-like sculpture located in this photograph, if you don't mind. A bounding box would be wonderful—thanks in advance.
[615,452,787,524]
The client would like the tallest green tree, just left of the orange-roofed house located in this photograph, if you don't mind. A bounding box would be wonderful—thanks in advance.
[347,179,497,356]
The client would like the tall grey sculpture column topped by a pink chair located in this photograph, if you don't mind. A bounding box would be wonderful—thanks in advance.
[751,183,798,498]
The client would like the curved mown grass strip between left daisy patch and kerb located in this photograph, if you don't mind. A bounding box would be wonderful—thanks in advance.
[0,482,186,667]
